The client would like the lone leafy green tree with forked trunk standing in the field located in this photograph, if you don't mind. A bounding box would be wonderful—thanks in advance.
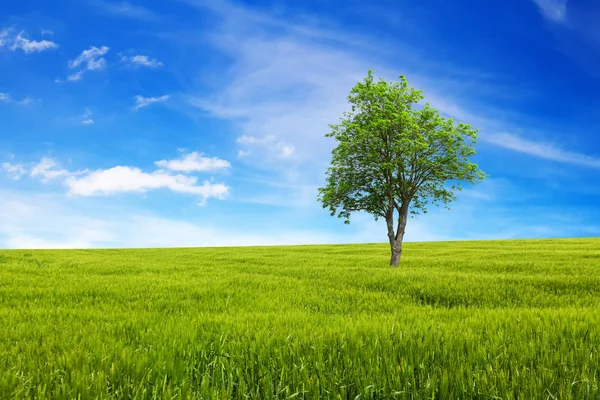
[319,71,486,267]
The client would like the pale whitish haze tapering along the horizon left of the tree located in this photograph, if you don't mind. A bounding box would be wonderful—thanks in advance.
[0,190,352,249]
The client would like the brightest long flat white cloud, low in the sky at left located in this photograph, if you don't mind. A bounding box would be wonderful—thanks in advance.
[65,166,229,200]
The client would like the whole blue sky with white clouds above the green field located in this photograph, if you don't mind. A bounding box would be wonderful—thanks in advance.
[0,0,600,248]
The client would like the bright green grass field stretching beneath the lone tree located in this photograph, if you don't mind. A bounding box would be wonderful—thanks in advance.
[0,239,600,399]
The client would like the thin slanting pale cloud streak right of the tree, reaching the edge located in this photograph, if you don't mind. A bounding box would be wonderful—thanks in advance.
[485,133,600,168]
